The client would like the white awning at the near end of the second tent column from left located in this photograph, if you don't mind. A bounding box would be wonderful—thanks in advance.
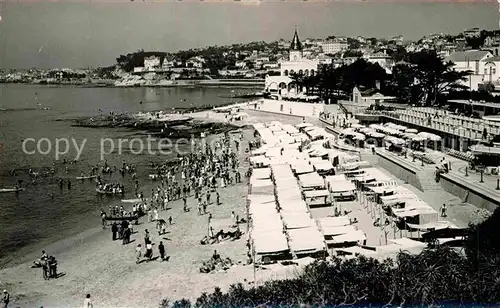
[287,227,326,254]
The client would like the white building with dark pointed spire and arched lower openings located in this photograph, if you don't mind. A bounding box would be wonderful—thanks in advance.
[280,30,319,76]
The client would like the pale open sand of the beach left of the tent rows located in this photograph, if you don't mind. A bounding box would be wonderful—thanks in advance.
[0,107,308,307]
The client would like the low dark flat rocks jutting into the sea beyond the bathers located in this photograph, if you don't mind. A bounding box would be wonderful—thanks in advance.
[72,114,240,139]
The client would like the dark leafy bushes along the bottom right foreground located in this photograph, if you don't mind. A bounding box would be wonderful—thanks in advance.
[161,210,500,308]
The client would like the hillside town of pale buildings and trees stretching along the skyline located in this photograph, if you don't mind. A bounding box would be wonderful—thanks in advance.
[0,28,500,95]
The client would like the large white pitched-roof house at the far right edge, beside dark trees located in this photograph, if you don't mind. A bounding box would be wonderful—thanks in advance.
[445,50,498,91]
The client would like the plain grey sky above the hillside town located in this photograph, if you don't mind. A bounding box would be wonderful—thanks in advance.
[0,0,499,68]
